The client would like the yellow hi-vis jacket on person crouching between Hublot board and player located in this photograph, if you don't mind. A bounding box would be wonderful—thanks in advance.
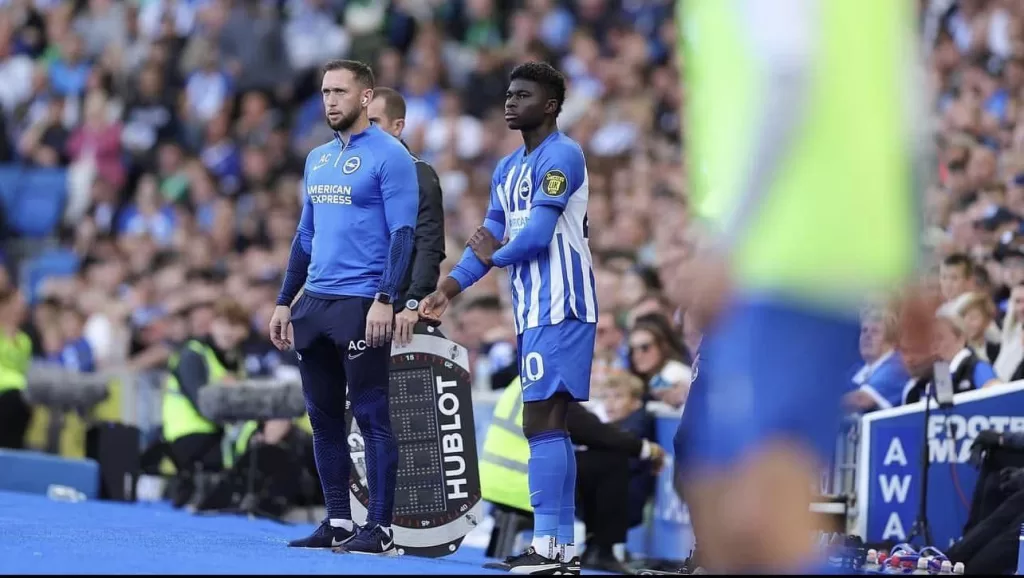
[480,377,534,511]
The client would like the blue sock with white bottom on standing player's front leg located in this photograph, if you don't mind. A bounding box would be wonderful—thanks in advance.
[526,430,566,559]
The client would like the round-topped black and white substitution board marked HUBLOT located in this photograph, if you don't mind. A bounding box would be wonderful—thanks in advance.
[345,324,483,558]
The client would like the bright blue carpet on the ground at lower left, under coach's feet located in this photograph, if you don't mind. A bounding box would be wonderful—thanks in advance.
[0,492,505,574]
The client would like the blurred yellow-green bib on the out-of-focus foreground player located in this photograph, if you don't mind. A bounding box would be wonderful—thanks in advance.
[678,0,925,308]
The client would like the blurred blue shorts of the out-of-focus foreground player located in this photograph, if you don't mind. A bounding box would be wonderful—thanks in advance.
[674,298,860,479]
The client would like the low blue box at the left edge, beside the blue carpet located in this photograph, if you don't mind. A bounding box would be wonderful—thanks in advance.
[0,450,99,499]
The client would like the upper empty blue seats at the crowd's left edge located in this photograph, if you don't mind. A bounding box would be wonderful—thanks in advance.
[0,167,68,239]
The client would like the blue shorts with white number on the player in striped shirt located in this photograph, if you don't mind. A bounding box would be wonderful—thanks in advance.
[518,319,597,402]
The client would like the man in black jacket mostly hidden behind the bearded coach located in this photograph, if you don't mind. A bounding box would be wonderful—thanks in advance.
[367,86,444,345]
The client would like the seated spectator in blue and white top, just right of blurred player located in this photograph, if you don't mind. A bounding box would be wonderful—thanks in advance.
[845,307,910,412]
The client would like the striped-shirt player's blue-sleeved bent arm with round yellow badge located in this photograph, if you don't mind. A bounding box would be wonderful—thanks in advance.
[492,147,587,266]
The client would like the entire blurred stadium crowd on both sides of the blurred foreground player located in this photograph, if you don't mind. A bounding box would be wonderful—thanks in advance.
[6,0,1024,573]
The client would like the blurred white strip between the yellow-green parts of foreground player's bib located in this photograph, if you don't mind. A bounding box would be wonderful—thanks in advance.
[716,0,827,253]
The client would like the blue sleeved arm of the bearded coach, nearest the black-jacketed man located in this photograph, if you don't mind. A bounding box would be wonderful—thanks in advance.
[377,146,420,299]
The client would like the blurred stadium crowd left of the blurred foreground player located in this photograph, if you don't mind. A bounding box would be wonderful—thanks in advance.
[0,0,687,406]
